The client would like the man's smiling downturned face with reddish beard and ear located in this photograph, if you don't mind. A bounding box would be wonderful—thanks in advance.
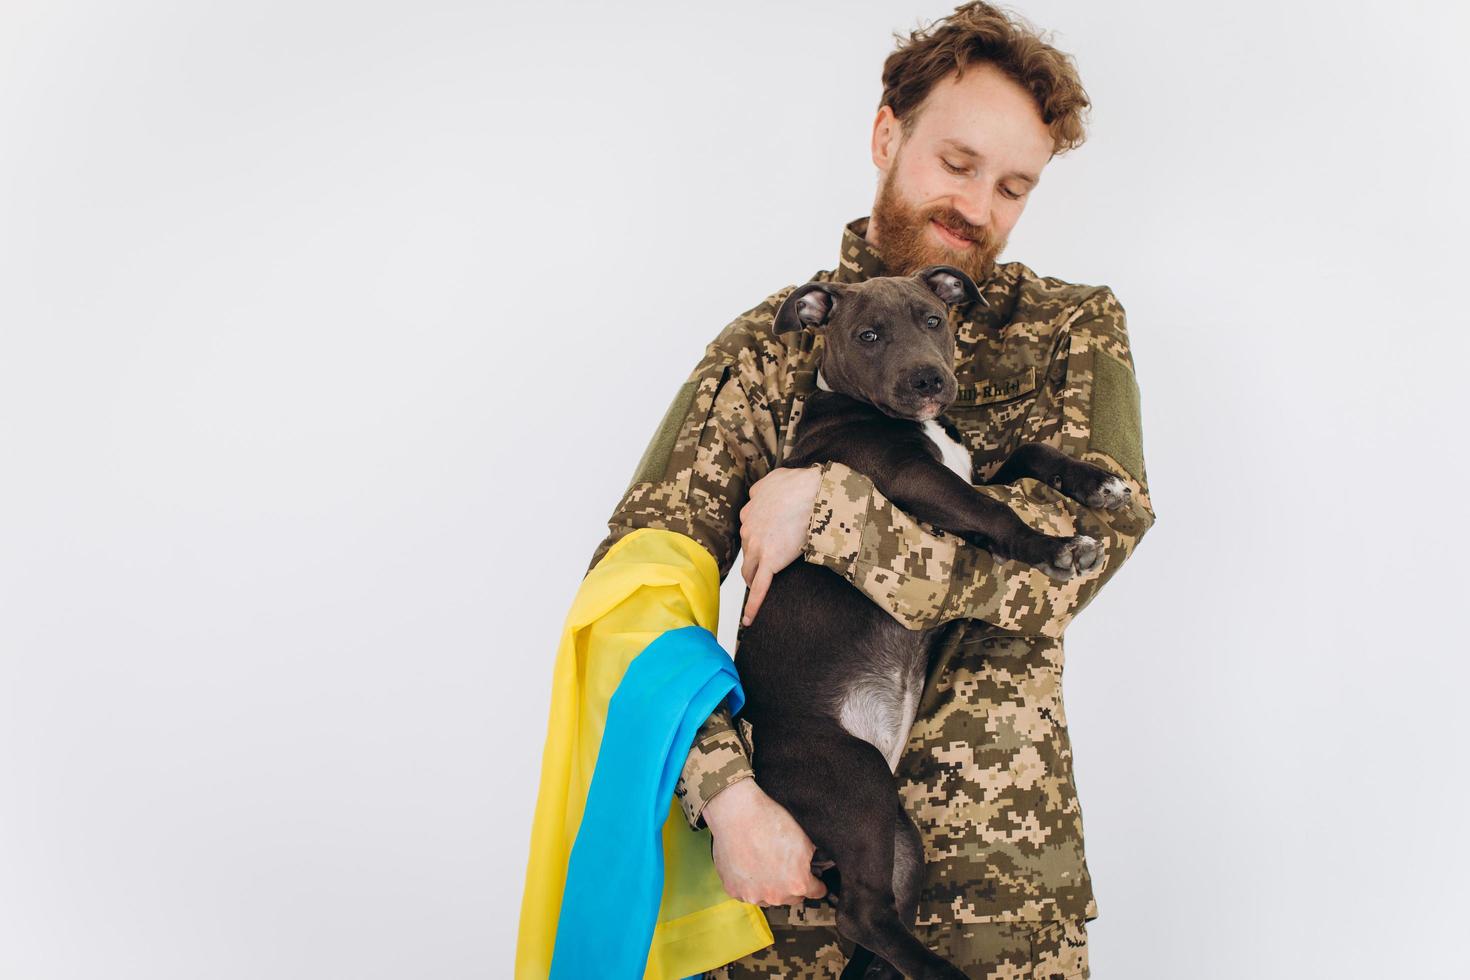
[867,65,1053,282]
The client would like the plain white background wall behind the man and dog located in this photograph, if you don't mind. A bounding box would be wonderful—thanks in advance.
[0,0,1470,980]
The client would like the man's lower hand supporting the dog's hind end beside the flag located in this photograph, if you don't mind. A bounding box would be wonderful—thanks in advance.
[704,779,826,905]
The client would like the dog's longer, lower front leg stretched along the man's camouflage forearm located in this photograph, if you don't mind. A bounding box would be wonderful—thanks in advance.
[875,457,1101,579]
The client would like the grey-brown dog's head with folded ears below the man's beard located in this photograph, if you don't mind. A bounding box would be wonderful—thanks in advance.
[772,266,985,422]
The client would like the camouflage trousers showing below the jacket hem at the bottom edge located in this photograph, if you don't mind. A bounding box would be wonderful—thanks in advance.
[704,909,1092,980]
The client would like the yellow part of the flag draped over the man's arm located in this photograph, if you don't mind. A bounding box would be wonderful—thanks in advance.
[516,527,773,980]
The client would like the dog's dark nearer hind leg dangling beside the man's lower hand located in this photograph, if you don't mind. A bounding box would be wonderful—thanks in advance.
[754,721,964,980]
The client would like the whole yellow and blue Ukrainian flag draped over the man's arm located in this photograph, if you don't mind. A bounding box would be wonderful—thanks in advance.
[516,527,773,980]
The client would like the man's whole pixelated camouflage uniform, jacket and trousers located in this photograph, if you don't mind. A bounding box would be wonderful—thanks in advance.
[589,217,1154,979]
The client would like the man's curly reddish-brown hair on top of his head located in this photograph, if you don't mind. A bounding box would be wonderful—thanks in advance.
[878,3,1091,156]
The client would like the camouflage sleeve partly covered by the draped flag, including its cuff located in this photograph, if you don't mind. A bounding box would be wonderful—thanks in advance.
[588,297,779,830]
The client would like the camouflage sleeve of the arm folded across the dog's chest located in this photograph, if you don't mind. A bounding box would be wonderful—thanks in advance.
[803,288,1154,636]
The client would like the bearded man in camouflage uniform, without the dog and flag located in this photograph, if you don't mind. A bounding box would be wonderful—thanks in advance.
[579,3,1154,979]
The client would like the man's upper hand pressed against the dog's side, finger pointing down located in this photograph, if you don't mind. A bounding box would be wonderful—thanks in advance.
[739,466,822,626]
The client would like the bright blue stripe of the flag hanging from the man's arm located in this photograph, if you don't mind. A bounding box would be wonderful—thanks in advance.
[551,626,745,980]
